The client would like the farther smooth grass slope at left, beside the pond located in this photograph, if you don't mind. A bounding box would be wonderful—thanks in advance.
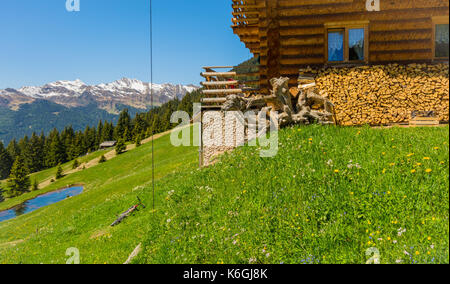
[0,133,197,263]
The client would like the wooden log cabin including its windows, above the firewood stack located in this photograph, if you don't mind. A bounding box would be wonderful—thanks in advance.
[232,0,449,92]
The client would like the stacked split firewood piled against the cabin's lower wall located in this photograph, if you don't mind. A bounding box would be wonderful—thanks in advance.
[300,64,449,125]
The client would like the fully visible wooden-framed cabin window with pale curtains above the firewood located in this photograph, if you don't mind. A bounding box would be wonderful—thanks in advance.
[325,22,369,63]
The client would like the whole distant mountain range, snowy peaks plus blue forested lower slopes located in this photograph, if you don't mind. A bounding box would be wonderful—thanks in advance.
[0,78,198,144]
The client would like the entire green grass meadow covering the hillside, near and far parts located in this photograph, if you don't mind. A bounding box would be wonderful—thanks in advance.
[0,126,449,263]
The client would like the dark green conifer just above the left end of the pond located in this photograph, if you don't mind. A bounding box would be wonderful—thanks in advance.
[5,155,30,197]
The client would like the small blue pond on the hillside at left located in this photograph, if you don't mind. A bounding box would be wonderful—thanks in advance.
[0,186,83,222]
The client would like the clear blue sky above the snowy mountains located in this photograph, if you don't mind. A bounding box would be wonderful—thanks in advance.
[0,0,251,89]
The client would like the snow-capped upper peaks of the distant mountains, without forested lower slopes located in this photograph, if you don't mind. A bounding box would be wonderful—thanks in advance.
[0,78,198,111]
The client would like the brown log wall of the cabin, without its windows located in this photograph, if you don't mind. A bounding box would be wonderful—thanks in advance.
[234,0,449,90]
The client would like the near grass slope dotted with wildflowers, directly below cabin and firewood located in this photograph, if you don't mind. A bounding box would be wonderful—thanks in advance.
[137,126,449,263]
